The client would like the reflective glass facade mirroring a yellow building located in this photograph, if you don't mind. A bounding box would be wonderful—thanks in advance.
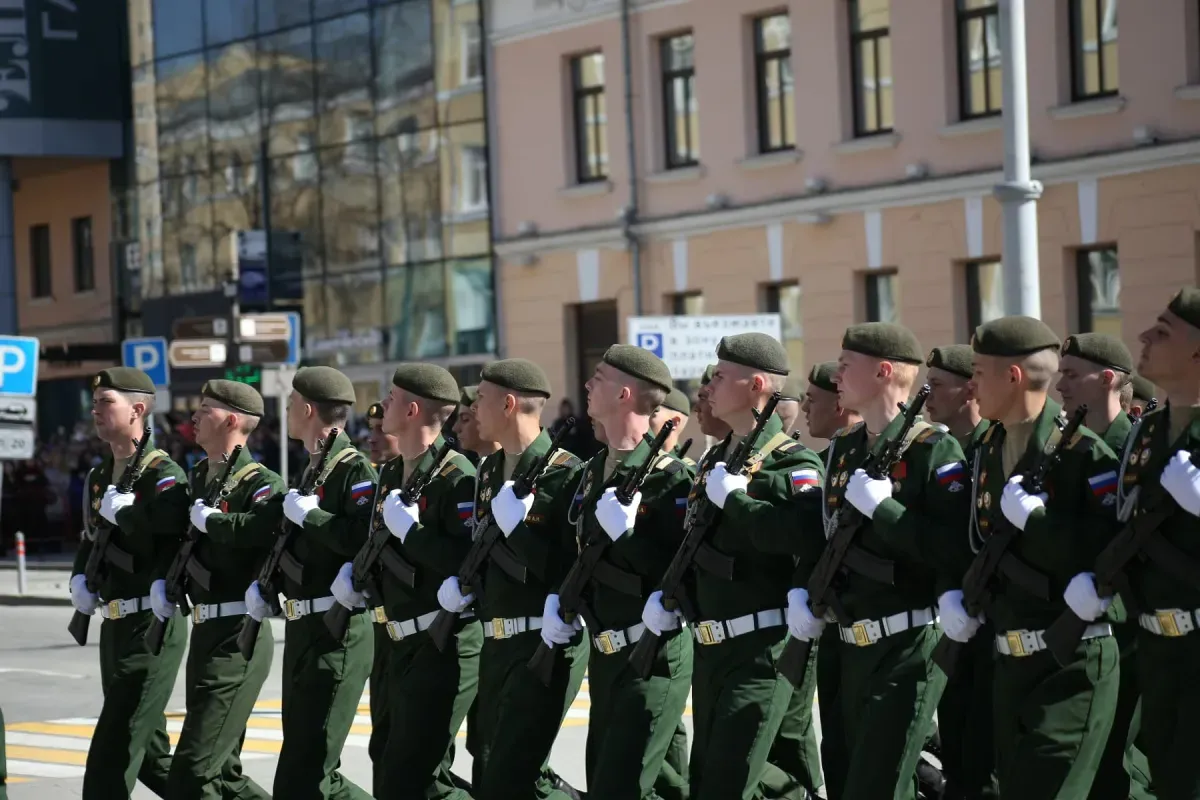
[130,0,496,366]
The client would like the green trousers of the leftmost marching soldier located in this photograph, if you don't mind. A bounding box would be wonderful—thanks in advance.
[83,610,187,800]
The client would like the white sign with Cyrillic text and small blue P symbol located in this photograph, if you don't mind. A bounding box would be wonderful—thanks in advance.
[628,314,782,380]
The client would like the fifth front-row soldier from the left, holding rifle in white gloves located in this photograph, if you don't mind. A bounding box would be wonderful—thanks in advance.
[438,359,588,800]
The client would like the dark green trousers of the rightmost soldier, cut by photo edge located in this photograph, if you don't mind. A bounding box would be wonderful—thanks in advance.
[1138,628,1200,800]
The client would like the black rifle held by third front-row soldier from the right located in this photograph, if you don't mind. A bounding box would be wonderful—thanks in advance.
[776,384,931,686]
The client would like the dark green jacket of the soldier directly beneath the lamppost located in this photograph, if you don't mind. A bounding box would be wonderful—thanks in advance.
[970,399,1116,631]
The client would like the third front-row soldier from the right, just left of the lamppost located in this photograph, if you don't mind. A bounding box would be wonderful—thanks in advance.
[788,323,967,800]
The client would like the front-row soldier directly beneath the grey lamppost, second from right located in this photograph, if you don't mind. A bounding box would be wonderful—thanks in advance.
[938,317,1120,798]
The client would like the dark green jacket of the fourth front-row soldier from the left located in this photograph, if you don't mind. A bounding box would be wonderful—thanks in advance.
[371,435,475,620]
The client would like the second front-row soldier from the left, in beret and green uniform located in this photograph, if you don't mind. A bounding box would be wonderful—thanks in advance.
[165,380,286,800]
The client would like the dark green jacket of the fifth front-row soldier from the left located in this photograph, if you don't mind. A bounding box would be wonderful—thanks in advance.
[475,428,580,620]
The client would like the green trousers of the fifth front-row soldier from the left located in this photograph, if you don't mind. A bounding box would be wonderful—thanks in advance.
[472,631,590,800]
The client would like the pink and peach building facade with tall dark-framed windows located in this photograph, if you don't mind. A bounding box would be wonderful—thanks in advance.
[488,0,1200,412]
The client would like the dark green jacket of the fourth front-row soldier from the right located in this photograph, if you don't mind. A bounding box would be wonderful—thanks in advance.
[689,415,821,621]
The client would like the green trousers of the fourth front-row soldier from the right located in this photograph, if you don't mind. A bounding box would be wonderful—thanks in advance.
[691,626,792,800]
